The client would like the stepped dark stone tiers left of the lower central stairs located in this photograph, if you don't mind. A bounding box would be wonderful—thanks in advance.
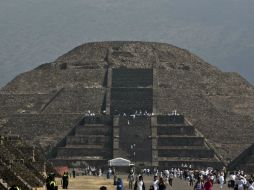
[52,115,112,167]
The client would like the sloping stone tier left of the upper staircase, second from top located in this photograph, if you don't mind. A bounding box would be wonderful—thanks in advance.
[1,68,106,94]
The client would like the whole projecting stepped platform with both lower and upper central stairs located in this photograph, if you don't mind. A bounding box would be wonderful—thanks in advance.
[50,68,223,168]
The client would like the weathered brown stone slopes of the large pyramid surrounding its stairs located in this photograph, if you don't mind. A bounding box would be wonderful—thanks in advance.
[0,42,254,166]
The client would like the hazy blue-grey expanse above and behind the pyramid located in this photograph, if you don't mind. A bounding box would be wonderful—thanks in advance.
[0,0,254,86]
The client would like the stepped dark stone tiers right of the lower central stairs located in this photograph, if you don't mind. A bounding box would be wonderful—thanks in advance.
[155,115,223,168]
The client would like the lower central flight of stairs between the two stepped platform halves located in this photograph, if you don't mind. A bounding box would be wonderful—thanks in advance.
[113,116,152,166]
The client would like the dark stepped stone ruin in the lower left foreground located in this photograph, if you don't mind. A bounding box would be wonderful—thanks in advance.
[0,136,51,190]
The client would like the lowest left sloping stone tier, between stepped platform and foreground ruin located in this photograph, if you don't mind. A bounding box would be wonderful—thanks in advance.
[1,114,81,151]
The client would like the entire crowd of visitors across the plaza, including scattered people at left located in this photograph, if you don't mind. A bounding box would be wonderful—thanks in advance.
[40,165,254,190]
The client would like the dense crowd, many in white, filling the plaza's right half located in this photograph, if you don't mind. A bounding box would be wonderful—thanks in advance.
[102,166,254,190]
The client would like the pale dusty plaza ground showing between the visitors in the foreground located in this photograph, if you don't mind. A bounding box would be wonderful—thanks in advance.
[58,176,231,190]
